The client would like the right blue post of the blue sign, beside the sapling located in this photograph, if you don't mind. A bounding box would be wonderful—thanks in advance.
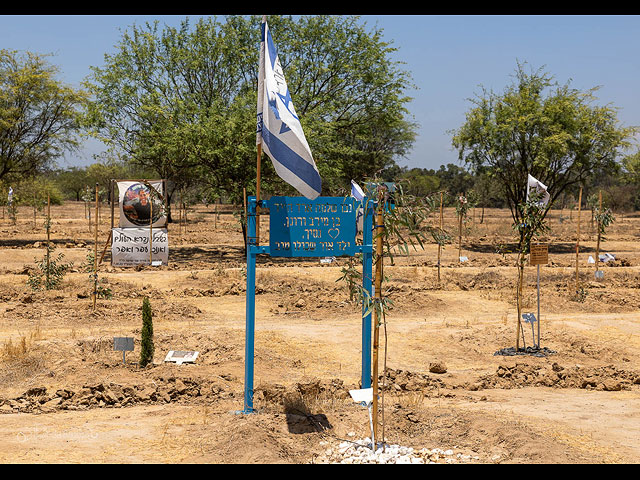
[361,197,374,388]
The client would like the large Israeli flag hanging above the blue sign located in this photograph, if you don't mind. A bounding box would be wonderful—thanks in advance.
[256,17,322,200]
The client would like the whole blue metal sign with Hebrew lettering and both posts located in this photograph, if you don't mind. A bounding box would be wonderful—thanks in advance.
[239,196,375,413]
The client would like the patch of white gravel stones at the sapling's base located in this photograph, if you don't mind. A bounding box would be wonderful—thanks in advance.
[317,438,478,464]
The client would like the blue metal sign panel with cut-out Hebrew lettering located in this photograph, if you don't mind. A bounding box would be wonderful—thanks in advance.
[267,197,359,257]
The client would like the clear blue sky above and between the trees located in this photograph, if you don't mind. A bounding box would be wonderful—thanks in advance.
[0,15,640,169]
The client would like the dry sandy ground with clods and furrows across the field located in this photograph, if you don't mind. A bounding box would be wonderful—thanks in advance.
[0,203,640,463]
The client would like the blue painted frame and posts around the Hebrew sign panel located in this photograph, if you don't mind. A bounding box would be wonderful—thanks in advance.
[239,196,376,414]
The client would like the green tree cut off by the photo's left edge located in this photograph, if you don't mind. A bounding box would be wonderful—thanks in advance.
[0,49,86,179]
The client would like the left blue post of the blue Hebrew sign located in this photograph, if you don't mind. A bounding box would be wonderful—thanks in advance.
[241,196,257,413]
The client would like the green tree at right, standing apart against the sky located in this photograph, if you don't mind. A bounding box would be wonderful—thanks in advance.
[452,63,637,234]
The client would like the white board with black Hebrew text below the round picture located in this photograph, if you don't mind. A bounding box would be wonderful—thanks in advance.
[111,228,169,267]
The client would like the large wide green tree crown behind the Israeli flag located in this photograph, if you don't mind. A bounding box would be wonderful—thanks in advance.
[86,16,416,209]
